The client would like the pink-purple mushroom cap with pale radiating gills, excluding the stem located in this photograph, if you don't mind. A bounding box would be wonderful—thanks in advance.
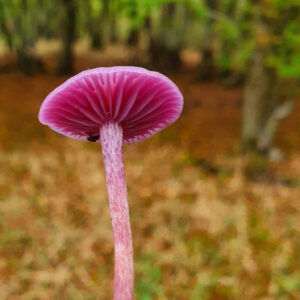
[39,67,183,144]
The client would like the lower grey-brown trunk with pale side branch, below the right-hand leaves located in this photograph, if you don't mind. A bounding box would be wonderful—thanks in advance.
[242,46,292,154]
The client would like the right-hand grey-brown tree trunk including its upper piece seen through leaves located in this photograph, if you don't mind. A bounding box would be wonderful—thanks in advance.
[241,5,294,154]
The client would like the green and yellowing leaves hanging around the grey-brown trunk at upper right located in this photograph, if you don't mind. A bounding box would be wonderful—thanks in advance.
[187,0,300,78]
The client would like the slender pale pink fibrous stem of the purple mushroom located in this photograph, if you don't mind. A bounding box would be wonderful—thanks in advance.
[100,123,134,300]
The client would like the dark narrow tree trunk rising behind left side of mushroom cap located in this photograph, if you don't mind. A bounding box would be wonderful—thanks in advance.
[58,0,76,75]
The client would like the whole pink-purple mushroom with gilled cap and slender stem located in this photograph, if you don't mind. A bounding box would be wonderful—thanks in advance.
[39,66,183,300]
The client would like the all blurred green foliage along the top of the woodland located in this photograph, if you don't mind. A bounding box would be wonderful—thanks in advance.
[0,0,300,78]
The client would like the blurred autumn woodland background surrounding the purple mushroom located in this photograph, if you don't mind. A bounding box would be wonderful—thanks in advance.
[0,0,300,300]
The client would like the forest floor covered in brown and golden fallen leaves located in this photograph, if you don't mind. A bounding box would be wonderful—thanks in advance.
[0,47,300,300]
